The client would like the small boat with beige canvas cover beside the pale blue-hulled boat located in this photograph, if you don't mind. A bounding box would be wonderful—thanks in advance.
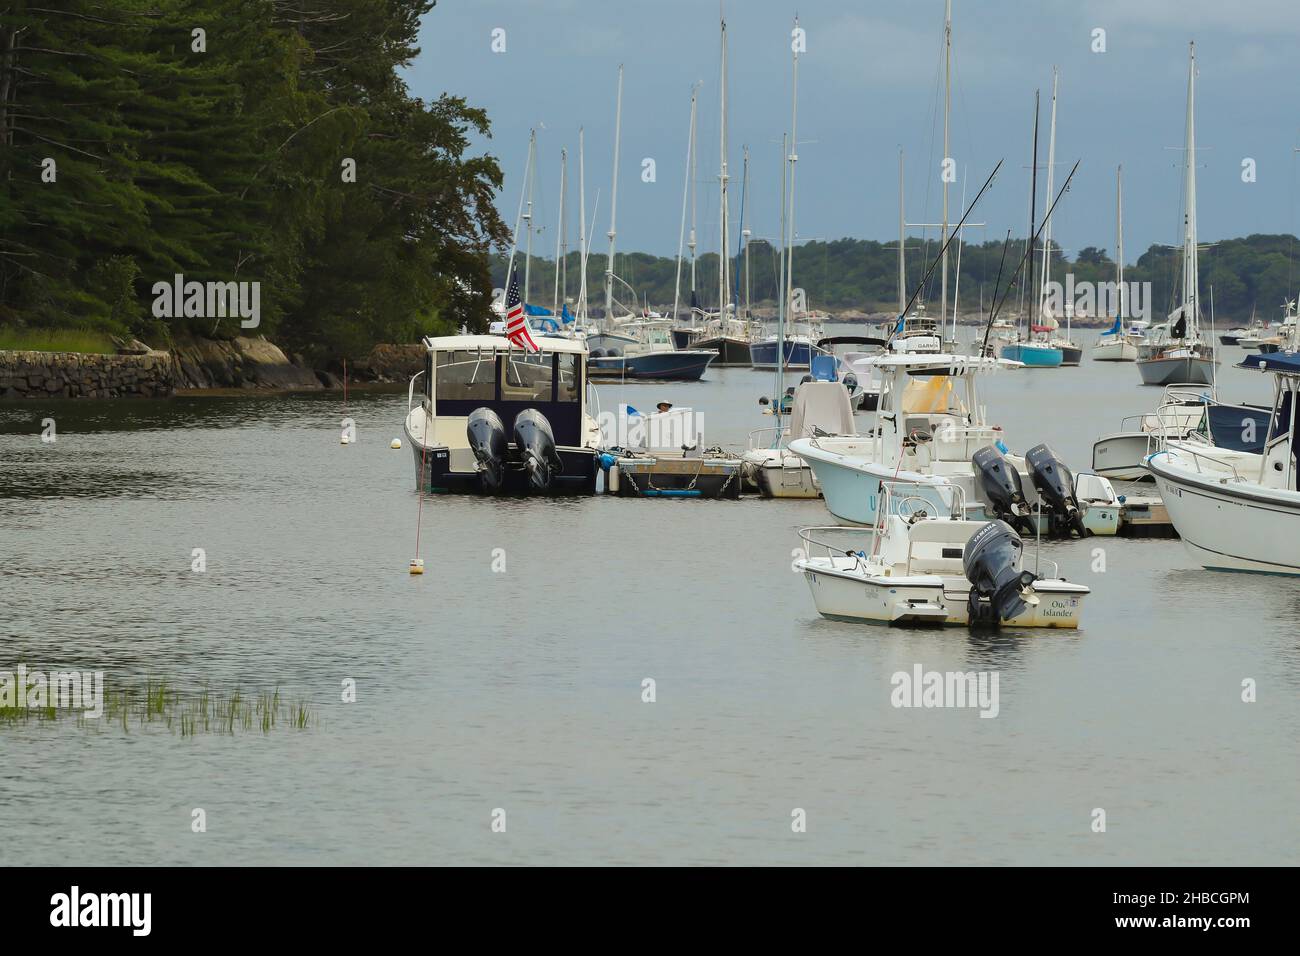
[741,381,858,498]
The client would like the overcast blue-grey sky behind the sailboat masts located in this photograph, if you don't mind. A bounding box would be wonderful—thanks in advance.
[408,0,1300,261]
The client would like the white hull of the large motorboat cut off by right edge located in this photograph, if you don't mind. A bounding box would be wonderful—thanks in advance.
[1147,453,1300,575]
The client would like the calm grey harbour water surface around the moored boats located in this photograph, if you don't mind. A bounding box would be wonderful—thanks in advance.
[0,327,1300,865]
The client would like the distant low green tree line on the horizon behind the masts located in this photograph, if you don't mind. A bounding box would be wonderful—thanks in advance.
[493,234,1300,321]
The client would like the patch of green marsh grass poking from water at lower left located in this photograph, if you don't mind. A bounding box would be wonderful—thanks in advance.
[0,678,320,737]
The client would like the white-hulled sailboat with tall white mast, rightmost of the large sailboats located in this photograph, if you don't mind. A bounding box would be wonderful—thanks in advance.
[1138,43,1214,385]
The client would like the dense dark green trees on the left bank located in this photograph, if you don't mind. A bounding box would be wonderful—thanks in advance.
[0,0,506,360]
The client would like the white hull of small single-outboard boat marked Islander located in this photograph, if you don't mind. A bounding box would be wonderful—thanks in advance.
[796,558,1088,630]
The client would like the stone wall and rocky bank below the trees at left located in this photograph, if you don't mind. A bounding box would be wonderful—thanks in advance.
[0,336,424,401]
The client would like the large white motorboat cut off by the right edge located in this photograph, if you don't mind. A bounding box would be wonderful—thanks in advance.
[1147,352,1300,575]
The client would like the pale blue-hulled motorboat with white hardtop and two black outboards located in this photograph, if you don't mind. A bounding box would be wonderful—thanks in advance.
[789,334,1118,537]
